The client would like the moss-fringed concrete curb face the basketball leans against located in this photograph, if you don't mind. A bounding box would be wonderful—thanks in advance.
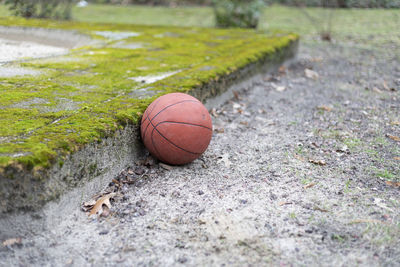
[0,19,298,216]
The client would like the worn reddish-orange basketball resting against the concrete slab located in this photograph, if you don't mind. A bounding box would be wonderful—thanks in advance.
[140,93,212,165]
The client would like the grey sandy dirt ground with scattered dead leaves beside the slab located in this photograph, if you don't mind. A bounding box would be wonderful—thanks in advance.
[0,43,400,266]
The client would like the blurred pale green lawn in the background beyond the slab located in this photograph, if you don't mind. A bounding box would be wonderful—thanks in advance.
[0,5,400,48]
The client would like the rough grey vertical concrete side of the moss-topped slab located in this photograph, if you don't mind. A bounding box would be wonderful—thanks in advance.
[0,37,299,217]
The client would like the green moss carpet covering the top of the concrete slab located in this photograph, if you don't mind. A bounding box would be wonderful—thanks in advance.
[0,17,298,176]
